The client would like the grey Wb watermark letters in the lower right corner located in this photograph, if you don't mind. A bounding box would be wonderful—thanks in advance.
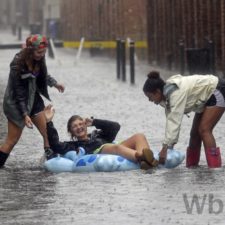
[183,194,223,215]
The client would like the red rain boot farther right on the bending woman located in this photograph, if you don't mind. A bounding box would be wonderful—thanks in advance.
[205,147,222,168]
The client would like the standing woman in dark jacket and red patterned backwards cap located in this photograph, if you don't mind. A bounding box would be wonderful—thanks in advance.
[0,35,64,167]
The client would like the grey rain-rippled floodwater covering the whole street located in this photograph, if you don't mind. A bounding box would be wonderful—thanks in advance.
[0,30,225,225]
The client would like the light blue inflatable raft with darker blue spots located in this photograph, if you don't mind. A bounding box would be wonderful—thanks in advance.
[44,148,185,173]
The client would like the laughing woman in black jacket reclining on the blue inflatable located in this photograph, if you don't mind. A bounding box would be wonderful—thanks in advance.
[44,105,158,170]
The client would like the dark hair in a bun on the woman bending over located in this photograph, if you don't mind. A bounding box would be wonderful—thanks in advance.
[143,71,165,93]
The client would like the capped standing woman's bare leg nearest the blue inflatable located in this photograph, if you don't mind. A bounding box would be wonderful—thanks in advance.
[31,111,49,147]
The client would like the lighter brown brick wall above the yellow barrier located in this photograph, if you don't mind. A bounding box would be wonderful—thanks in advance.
[61,0,147,41]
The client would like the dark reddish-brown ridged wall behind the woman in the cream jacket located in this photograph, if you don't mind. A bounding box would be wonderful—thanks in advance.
[147,0,225,72]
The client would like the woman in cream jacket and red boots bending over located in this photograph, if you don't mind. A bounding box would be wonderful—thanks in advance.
[143,71,225,168]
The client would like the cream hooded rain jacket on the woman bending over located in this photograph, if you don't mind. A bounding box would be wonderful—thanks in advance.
[163,74,219,146]
